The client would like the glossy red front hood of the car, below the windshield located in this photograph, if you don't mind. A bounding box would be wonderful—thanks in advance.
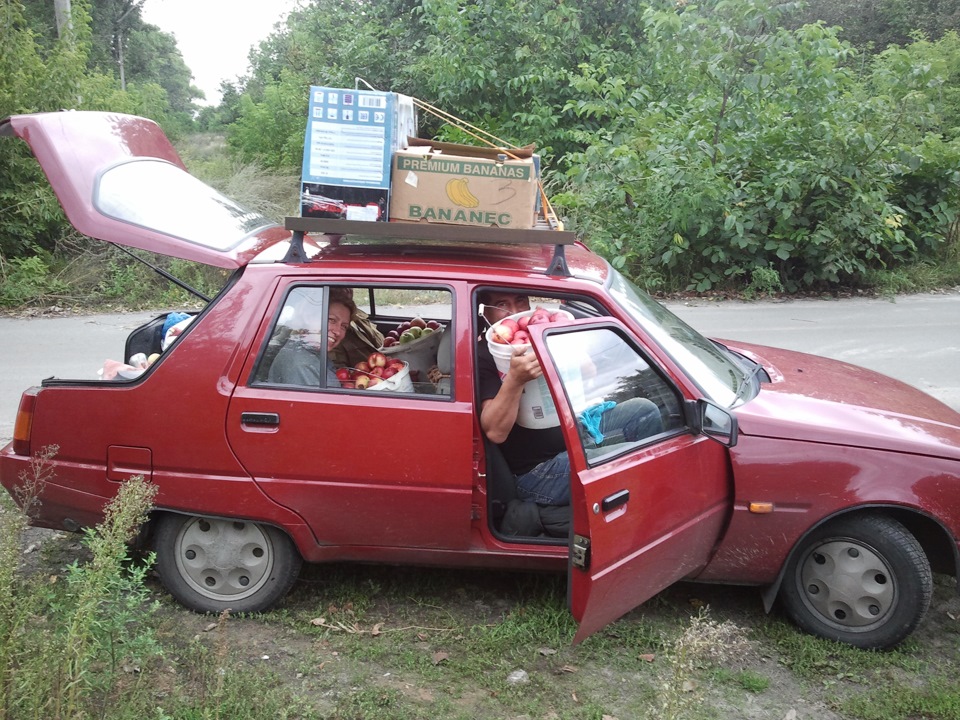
[720,341,960,459]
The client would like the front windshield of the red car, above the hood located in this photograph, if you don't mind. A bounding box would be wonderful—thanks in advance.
[610,271,747,407]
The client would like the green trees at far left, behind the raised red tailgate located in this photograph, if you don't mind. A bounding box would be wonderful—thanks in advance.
[0,0,199,261]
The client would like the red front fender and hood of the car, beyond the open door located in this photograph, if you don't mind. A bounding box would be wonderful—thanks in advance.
[697,343,960,584]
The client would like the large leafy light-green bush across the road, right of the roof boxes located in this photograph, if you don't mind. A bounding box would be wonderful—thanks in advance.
[564,0,956,290]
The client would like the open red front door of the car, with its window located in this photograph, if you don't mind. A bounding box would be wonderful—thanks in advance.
[529,319,732,642]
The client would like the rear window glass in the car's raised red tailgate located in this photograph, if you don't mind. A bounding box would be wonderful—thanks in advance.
[94,159,272,251]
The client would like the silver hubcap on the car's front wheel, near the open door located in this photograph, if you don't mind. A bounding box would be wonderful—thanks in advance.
[798,540,897,630]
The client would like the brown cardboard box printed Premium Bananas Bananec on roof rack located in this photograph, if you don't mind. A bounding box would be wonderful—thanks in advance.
[390,138,539,228]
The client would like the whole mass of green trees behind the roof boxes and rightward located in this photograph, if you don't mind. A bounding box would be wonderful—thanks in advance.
[218,0,960,290]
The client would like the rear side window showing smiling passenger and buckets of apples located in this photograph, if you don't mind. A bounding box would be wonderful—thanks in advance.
[254,285,453,398]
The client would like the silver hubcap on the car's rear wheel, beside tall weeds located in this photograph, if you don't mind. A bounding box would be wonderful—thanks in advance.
[176,518,274,600]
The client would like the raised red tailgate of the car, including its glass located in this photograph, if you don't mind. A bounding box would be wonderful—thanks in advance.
[0,112,290,268]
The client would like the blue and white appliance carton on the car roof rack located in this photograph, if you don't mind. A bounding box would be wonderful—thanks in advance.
[300,87,417,220]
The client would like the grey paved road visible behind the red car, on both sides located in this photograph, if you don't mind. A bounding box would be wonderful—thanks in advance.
[0,292,960,442]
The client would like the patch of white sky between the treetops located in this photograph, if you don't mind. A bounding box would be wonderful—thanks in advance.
[141,0,297,105]
